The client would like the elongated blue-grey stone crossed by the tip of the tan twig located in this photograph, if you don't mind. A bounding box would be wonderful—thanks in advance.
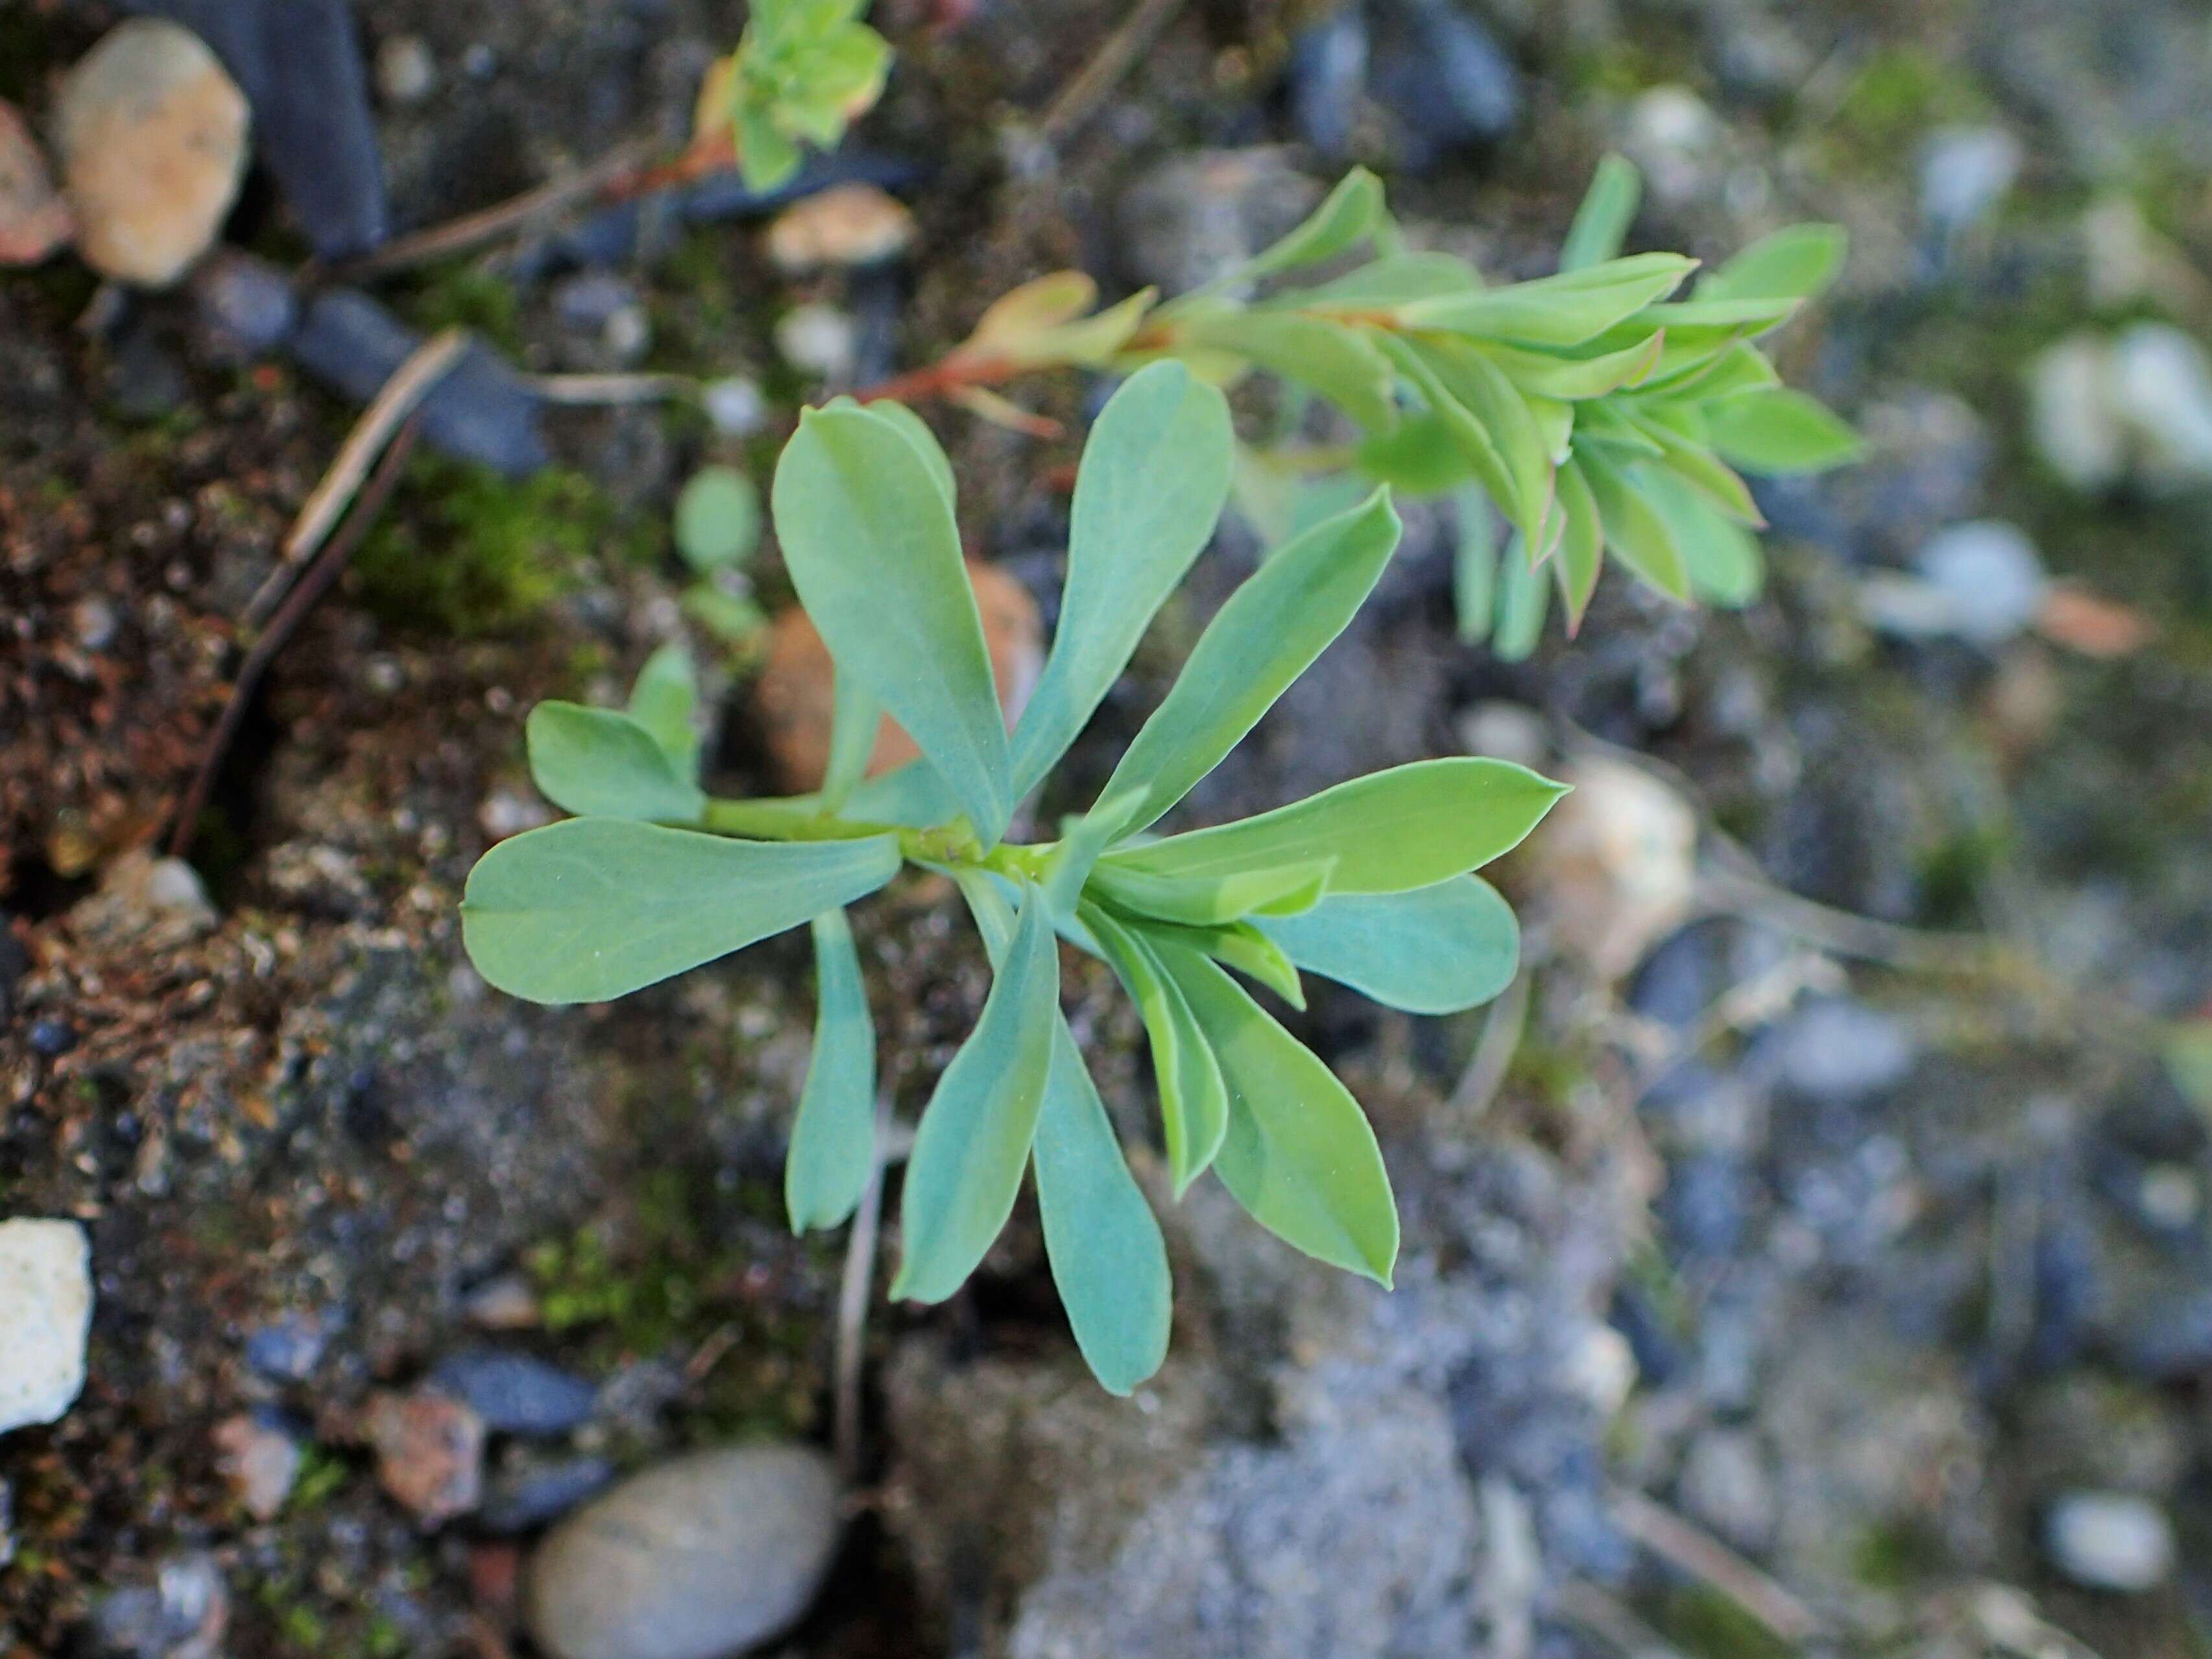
[285,287,551,478]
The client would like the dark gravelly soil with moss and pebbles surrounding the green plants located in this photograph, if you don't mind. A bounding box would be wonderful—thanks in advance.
[0,0,2212,1659]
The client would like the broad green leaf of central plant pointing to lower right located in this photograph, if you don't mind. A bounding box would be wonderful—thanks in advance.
[1161,947,1398,1285]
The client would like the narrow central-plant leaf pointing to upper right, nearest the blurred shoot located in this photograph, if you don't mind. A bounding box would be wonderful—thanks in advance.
[1101,491,1401,832]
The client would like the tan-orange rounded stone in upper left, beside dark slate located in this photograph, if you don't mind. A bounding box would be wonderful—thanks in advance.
[53,18,248,287]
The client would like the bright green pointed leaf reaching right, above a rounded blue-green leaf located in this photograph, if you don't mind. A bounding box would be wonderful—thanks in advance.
[1097,755,1566,896]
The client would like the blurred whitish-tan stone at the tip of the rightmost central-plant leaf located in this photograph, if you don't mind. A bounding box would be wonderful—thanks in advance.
[1520,757,1696,980]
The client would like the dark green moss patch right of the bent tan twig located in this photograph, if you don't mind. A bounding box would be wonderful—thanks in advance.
[354,455,615,637]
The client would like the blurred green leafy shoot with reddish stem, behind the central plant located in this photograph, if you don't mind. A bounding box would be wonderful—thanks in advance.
[871,157,1858,655]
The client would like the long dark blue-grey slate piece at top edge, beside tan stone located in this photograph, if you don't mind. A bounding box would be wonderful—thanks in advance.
[144,0,392,261]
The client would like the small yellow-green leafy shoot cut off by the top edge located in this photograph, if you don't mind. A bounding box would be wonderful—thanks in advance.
[695,0,891,190]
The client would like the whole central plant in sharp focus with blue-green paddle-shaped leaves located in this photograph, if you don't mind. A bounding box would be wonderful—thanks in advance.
[463,363,1561,1391]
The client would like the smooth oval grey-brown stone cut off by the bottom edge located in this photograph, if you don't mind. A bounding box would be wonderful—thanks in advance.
[522,1447,841,1659]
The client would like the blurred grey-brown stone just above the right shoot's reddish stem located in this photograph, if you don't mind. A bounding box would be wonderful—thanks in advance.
[1115,148,1321,294]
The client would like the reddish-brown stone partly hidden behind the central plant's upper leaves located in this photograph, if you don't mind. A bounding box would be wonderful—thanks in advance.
[754,560,1044,794]
